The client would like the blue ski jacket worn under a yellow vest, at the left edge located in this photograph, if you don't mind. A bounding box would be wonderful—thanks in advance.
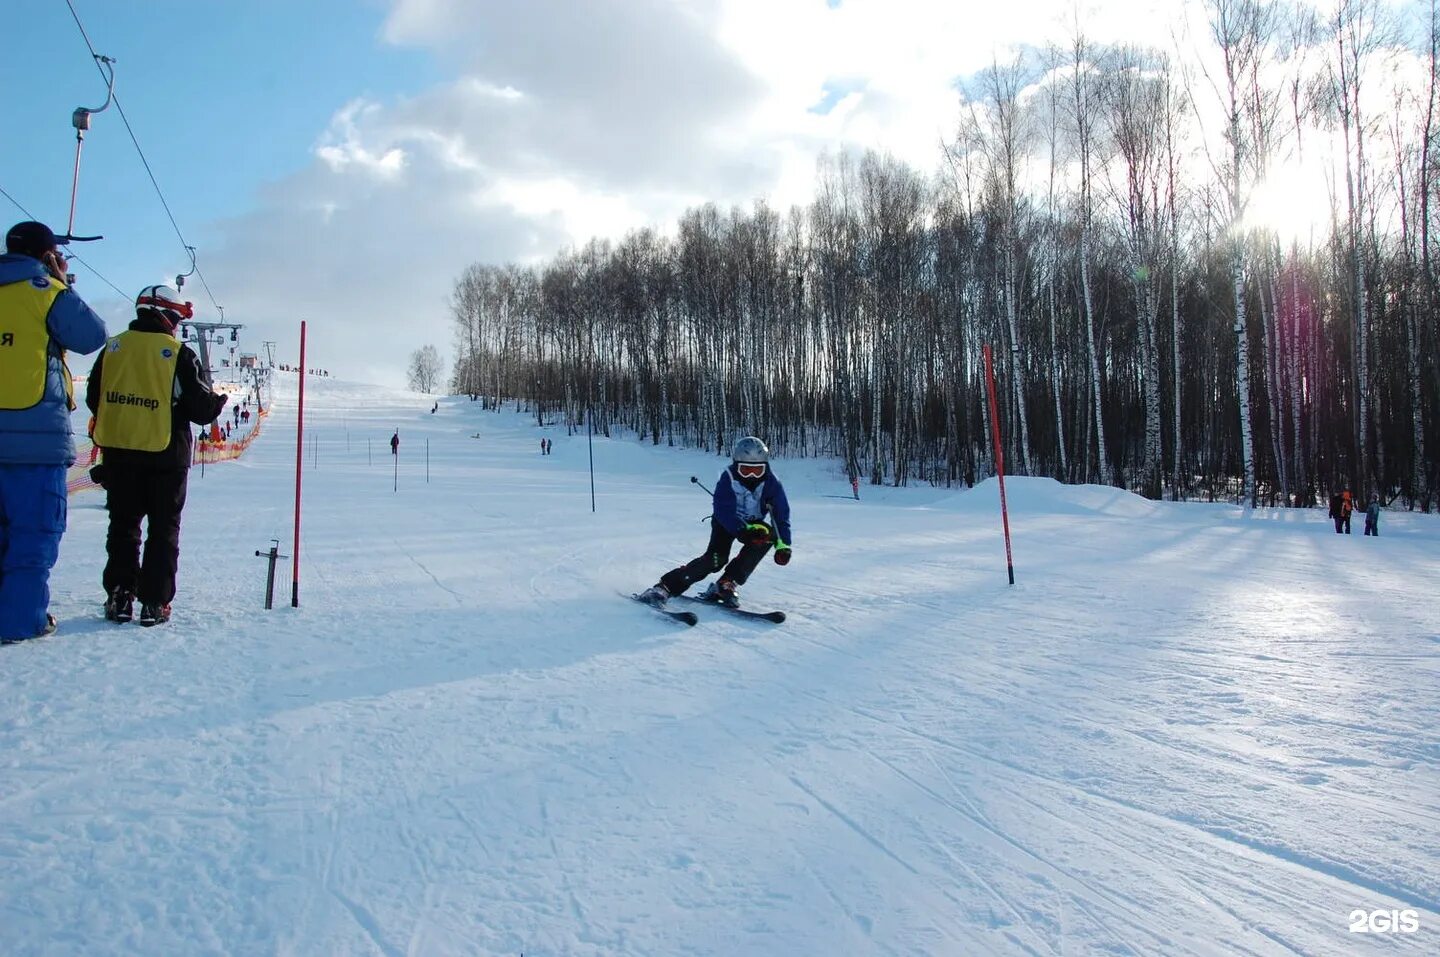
[0,253,105,466]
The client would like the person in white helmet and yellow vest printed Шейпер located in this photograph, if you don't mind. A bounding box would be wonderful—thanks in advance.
[85,286,228,626]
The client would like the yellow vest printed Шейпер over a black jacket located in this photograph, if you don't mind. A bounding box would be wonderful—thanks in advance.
[95,330,180,452]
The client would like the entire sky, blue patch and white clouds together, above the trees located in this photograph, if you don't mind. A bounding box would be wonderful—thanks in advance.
[0,0,1189,384]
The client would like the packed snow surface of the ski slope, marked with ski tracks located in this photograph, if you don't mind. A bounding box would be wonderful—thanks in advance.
[0,373,1440,957]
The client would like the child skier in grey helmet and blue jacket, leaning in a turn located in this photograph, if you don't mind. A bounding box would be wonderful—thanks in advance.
[638,436,791,607]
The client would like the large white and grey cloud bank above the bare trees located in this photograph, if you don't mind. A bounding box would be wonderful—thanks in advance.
[194,0,1347,380]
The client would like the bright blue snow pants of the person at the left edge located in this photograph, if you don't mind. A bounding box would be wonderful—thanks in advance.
[0,465,69,640]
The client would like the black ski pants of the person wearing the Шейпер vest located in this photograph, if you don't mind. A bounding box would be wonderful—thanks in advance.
[102,466,190,604]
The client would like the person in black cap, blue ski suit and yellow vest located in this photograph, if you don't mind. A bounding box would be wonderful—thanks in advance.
[0,222,105,642]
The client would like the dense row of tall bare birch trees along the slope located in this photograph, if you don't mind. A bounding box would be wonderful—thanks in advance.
[451,0,1440,511]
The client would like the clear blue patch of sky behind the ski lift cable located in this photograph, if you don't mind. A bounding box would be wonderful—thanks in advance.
[0,0,438,312]
